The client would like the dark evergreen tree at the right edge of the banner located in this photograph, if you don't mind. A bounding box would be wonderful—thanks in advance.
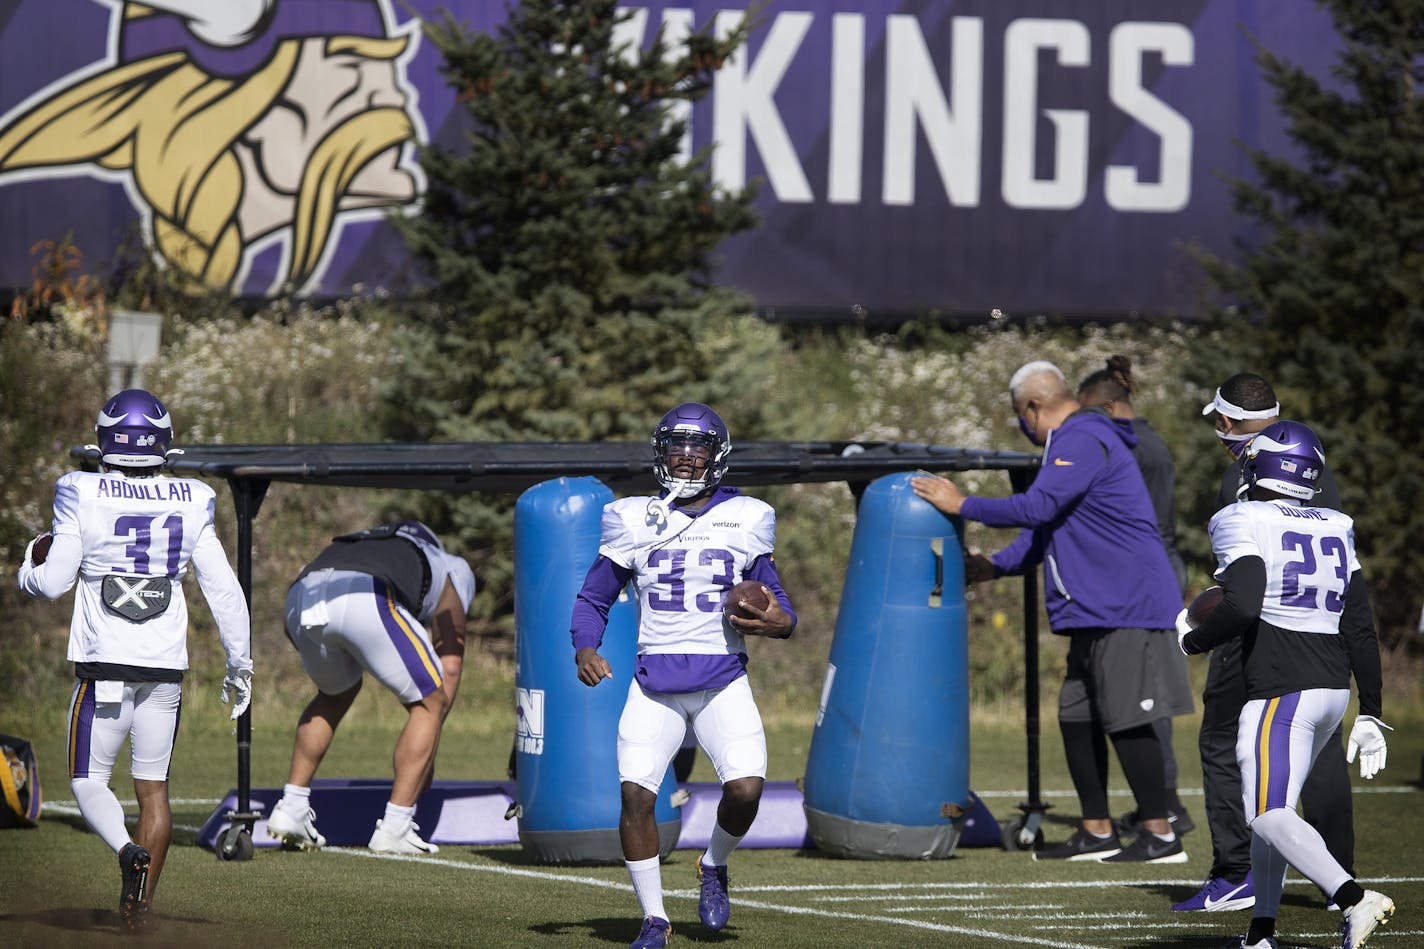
[1206,0,1424,638]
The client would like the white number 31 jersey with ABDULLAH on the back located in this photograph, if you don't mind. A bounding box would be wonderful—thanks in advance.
[20,472,252,670]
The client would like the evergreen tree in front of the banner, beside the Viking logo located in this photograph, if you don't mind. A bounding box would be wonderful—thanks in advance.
[389,0,756,624]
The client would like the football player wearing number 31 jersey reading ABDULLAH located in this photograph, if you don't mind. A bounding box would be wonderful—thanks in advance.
[20,389,252,930]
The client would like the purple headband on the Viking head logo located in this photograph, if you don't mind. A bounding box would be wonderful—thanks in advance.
[118,0,390,78]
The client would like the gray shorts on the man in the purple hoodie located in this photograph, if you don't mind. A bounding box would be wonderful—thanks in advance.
[1058,628,1195,734]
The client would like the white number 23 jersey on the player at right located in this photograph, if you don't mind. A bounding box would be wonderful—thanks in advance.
[1208,500,1360,633]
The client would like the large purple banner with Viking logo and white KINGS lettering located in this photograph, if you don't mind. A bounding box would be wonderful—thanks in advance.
[0,0,1337,316]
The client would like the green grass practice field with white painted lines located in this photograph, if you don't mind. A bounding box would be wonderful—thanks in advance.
[0,670,1424,949]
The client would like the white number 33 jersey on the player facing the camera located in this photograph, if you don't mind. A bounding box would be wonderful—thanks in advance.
[598,494,776,655]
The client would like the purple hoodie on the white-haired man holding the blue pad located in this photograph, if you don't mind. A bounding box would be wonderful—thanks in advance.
[960,409,1182,634]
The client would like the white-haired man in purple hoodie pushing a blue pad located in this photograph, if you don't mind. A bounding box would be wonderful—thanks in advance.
[911,361,1192,864]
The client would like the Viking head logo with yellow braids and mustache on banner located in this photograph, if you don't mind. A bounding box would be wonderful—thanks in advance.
[0,0,429,291]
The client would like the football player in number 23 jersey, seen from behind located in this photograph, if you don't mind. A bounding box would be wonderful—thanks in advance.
[1178,422,1394,949]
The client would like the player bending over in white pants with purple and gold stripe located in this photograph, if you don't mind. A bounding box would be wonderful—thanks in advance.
[266,520,474,854]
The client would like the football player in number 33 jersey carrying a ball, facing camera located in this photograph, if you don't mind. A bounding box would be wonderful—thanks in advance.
[571,402,796,949]
